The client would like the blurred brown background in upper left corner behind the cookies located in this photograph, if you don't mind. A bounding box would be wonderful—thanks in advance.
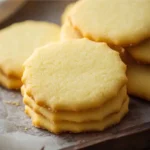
[0,0,75,29]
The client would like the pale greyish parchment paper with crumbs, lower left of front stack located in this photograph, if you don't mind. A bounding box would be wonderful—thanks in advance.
[0,87,77,150]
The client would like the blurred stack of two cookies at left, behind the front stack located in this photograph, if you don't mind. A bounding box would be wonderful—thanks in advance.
[0,21,60,89]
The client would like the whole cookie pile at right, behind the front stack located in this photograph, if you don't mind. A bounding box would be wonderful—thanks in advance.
[61,0,150,100]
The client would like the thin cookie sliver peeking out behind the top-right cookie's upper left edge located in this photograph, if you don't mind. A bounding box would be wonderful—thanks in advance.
[61,2,75,24]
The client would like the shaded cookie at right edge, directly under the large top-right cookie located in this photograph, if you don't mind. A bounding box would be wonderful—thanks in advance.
[127,39,150,64]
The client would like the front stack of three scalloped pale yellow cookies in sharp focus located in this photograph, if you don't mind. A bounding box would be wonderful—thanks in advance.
[22,38,129,133]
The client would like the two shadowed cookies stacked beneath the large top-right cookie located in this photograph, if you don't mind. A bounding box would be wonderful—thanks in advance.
[126,39,150,100]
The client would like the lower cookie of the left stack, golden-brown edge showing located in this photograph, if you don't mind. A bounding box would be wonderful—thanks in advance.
[0,71,22,89]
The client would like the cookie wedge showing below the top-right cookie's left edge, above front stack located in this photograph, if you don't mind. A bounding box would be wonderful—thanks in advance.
[60,21,82,41]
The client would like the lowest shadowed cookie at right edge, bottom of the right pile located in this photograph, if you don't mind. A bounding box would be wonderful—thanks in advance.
[126,53,150,100]
